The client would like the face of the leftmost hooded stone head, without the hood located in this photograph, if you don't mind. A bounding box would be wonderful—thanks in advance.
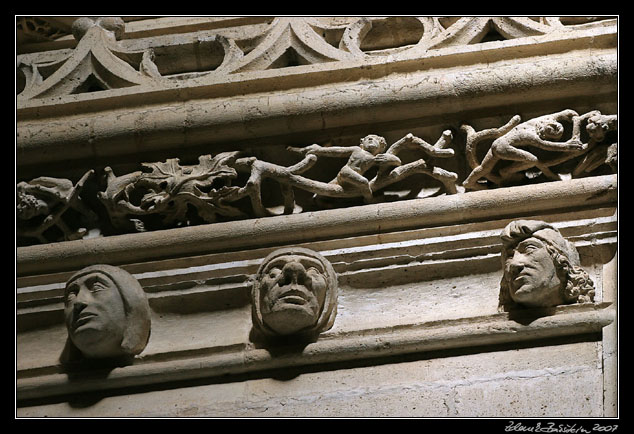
[64,272,126,358]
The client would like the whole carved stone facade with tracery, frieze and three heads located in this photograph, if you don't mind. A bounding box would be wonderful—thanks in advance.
[16,16,618,419]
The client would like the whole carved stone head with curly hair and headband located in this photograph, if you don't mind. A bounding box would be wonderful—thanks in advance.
[499,220,594,310]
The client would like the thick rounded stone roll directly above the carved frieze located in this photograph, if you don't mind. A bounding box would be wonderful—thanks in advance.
[17,49,618,168]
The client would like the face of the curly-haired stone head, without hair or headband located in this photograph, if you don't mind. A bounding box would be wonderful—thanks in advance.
[504,238,564,307]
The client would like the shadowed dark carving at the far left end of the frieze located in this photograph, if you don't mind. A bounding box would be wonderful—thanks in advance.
[16,170,97,243]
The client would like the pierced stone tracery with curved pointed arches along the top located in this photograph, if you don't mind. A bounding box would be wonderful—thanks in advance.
[17,17,603,101]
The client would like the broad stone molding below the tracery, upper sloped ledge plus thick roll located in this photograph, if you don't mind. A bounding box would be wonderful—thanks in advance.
[17,22,617,171]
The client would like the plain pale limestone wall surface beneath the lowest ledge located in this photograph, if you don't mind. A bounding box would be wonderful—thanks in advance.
[18,342,603,418]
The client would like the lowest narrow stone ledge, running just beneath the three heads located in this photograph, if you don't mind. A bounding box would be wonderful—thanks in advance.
[17,303,616,400]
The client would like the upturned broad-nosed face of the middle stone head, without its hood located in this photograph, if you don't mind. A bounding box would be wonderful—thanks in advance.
[260,254,328,334]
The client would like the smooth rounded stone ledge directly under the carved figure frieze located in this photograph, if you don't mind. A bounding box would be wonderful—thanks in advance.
[17,175,617,276]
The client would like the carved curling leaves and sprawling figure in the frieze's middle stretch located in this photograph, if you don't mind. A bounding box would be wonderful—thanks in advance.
[99,131,457,230]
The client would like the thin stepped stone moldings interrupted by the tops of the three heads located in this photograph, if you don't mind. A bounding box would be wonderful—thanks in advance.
[17,206,617,294]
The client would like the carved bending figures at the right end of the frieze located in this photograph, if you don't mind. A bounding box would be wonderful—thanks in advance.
[462,110,617,190]
